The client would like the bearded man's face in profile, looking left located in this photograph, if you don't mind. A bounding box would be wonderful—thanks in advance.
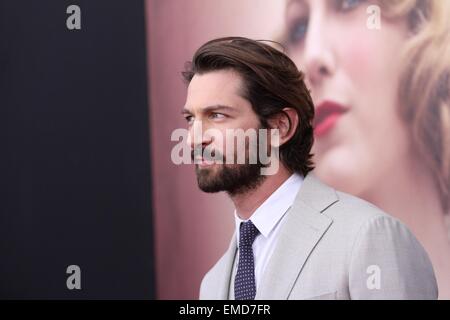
[183,70,264,195]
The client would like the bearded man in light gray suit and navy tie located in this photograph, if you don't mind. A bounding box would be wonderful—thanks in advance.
[179,37,437,300]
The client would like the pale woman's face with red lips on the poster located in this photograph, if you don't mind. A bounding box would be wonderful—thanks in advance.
[285,0,410,195]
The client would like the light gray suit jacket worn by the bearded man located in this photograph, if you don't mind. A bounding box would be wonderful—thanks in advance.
[200,173,438,300]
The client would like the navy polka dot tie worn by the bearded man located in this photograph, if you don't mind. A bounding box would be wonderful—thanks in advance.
[234,221,259,300]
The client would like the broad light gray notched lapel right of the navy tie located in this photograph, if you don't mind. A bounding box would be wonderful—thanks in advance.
[256,173,338,300]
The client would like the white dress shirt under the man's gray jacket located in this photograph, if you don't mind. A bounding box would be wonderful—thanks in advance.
[234,173,303,290]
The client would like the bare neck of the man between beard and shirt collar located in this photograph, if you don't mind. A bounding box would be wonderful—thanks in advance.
[231,165,292,220]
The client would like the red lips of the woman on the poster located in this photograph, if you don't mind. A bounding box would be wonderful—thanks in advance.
[314,101,349,138]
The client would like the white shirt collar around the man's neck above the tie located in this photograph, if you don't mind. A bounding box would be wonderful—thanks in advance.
[234,173,303,244]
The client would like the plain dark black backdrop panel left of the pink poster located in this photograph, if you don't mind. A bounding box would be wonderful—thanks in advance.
[0,0,154,299]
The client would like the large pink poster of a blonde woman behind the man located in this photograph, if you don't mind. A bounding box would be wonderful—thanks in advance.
[147,0,450,298]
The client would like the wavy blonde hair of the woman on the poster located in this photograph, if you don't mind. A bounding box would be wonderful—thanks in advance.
[380,0,450,212]
